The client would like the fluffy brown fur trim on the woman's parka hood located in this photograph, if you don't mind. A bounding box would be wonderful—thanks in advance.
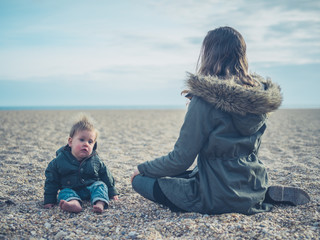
[186,73,282,115]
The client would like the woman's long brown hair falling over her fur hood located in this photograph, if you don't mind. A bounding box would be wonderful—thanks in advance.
[197,27,257,86]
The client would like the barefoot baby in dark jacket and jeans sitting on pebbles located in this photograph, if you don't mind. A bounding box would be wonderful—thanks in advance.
[44,115,119,213]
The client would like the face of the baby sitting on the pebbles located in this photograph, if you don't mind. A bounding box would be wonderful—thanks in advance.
[68,130,96,161]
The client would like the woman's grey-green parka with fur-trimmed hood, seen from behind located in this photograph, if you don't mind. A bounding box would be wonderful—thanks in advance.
[138,75,282,214]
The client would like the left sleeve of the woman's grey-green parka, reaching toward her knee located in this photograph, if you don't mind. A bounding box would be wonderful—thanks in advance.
[138,96,213,178]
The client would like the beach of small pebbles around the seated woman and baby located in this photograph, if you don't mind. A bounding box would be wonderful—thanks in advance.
[0,109,320,240]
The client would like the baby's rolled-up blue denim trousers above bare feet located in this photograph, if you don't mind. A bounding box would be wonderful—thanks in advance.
[58,181,109,208]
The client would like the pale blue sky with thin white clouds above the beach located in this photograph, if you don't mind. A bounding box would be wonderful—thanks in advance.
[0,0,320,108]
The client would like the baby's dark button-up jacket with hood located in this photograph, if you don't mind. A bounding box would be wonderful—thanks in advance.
[44,145,118,204]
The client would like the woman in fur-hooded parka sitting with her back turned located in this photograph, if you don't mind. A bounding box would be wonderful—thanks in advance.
[131,27,309,214]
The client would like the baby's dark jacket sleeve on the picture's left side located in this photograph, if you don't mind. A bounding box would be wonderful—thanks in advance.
[44,159,61,204]
